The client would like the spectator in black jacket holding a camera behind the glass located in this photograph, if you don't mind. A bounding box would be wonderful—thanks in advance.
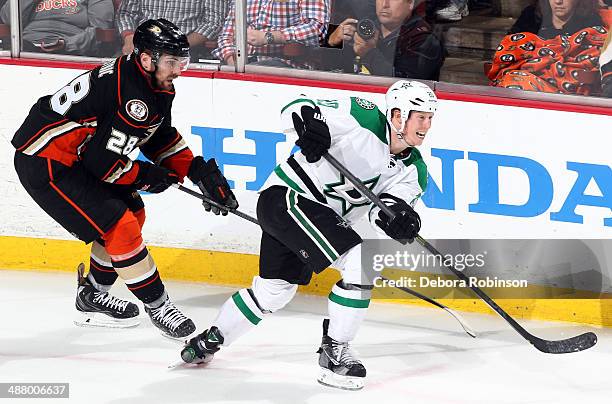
[329,0,444,80]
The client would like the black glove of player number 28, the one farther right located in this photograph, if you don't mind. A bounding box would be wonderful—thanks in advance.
[187,156,238,216]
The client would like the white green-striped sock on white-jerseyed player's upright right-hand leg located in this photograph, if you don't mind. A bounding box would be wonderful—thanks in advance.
[327,284,372,342]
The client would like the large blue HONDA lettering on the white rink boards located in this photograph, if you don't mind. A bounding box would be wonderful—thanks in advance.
[191,126,612,227]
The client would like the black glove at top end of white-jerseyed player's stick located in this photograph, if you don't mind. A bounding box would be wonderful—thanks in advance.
[291,105,331,163]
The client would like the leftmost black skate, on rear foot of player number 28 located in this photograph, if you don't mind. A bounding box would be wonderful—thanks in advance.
[74,263,140,328]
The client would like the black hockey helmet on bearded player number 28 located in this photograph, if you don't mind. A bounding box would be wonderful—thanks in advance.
[134,18,189,64]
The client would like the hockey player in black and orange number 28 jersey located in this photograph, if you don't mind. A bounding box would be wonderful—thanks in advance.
[12,19,238,338]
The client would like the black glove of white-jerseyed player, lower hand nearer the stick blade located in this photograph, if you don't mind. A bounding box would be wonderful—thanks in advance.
[374,193,421,243]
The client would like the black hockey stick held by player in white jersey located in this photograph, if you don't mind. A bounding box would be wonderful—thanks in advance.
[323,153,597,353]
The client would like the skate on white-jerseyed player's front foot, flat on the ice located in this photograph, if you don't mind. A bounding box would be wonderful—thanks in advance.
[317,319,366,390]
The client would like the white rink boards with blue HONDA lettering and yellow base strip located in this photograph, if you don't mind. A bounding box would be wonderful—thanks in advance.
[0,64,612,325]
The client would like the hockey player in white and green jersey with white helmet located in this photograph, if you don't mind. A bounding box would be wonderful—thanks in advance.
[181,80,438,390]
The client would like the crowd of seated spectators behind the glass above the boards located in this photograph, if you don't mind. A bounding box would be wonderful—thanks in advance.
[0,0,612,97]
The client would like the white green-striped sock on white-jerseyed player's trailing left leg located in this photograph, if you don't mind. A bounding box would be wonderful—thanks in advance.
[212,289,264,346]
